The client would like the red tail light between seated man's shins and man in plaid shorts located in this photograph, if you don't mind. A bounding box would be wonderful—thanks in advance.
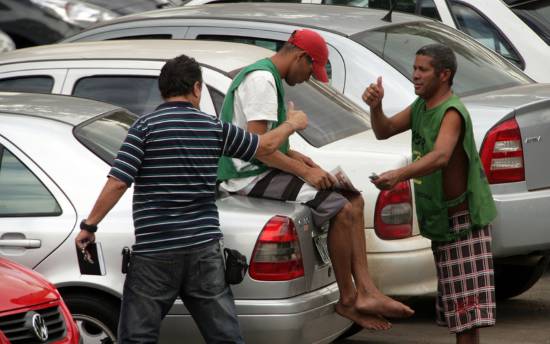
[374,182,412,240]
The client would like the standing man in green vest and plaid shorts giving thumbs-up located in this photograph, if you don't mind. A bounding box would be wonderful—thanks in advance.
[363,44,496,343]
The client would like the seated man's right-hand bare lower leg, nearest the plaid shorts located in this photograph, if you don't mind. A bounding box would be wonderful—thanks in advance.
[348,195,414,318]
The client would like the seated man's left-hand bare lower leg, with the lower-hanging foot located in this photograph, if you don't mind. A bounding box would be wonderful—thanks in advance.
[328,204,391,330]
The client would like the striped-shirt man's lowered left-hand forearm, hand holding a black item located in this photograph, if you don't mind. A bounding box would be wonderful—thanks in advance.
[75,176,128,248]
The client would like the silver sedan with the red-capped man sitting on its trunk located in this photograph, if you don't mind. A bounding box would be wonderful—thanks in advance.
[0,90,351,344]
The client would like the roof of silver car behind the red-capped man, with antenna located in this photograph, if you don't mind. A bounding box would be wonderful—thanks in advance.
[86,2,432,36]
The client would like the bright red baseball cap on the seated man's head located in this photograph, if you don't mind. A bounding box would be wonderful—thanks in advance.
[288,29,328,82]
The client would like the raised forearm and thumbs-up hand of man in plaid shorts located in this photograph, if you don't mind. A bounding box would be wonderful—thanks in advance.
[363,77,411,140]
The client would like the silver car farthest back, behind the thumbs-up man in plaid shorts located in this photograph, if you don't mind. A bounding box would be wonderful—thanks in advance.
[61,3,550,298]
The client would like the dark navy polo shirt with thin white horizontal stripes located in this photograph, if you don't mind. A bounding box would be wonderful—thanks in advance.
[109,102,259,253]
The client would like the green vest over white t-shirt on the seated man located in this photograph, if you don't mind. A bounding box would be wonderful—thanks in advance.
[218,58,289,181]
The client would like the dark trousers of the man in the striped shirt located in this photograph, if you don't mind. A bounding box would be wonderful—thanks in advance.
[118,242,244,344]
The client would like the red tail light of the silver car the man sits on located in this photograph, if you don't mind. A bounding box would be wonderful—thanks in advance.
[249,216,304,281]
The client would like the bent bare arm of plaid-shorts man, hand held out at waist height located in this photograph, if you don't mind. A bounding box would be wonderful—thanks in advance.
[372,109,462,190]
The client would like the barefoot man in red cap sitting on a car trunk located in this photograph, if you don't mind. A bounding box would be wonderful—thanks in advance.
[218,29,413,330]
